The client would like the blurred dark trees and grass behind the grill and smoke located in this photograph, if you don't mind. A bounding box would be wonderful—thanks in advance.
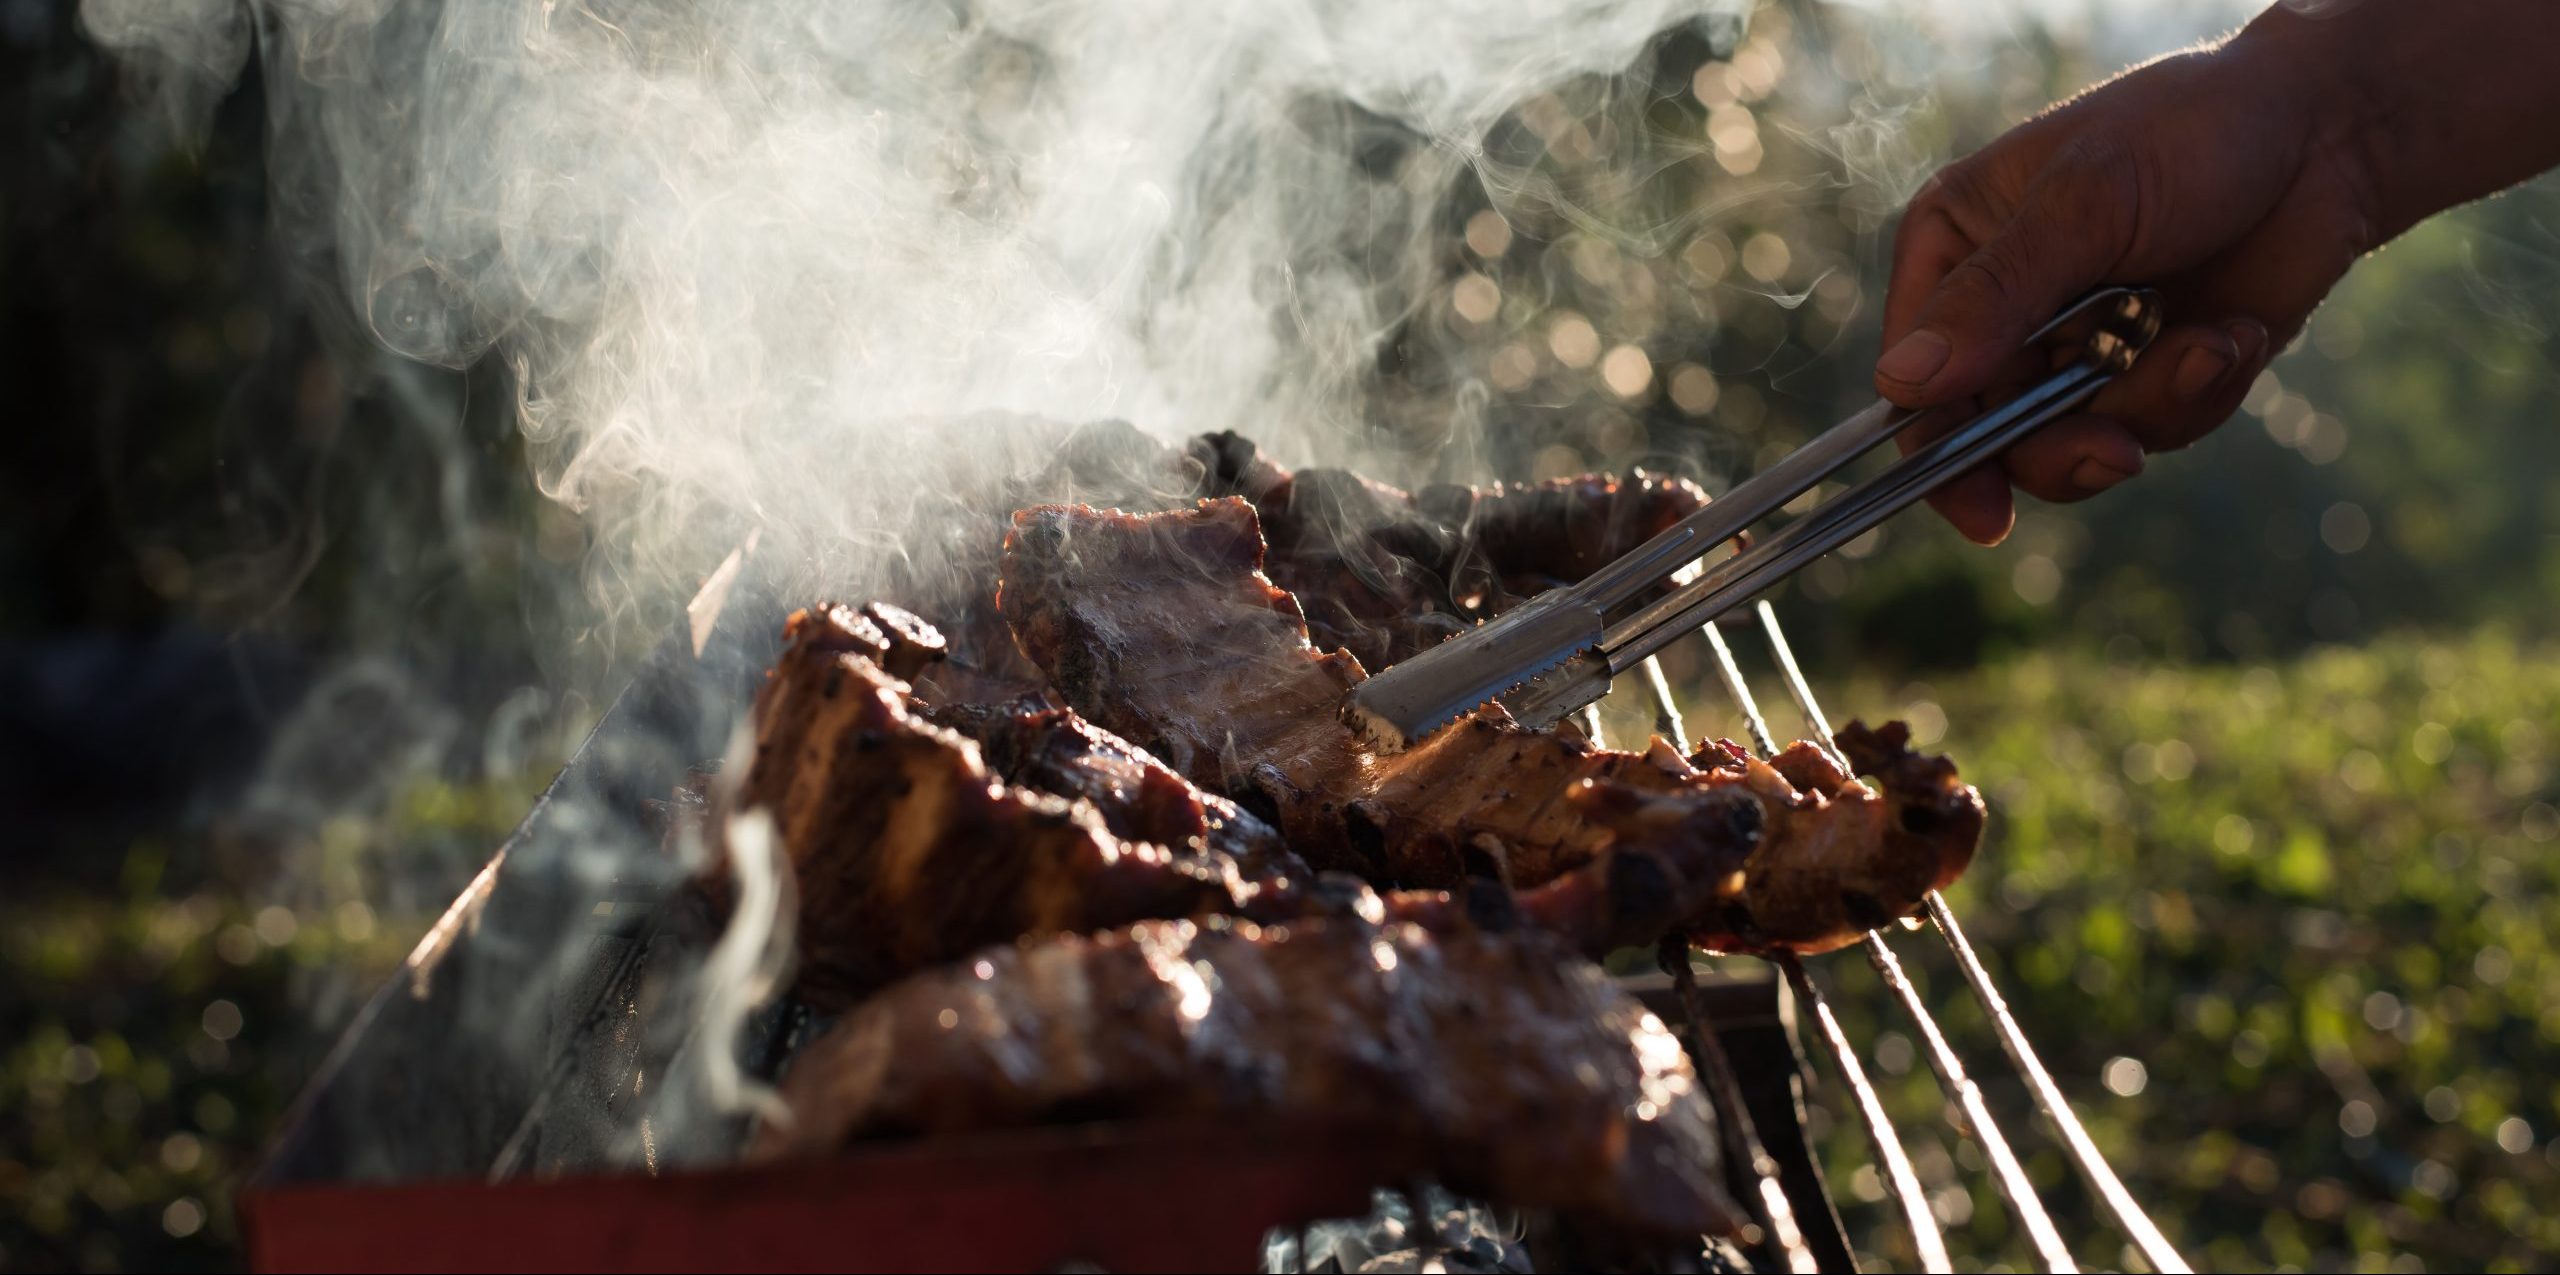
[0,0,2560,1270]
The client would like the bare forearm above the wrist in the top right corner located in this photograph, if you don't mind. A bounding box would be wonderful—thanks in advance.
[2227,0,2560,243]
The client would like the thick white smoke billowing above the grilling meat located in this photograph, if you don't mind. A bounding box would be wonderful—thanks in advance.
[82,0,1738,617]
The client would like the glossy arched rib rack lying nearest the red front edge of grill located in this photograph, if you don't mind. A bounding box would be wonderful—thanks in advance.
[758,899,1741,1237]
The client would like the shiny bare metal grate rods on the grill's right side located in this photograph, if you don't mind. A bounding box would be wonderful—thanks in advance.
[1646,602,2189,1275]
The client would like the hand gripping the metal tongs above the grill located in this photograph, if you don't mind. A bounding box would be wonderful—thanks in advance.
[1876,27,2381,543]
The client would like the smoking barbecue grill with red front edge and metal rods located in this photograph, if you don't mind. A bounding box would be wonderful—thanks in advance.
[241,532,2186,1272]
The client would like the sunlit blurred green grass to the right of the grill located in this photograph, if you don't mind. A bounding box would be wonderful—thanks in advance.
[1751,632,2560,1270]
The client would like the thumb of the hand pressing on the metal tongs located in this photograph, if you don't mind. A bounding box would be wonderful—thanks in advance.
[1876,149,2135,407]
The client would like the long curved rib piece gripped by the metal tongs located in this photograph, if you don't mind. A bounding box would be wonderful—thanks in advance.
[998,499,1981,952]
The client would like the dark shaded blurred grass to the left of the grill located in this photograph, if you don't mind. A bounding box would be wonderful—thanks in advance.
[0,758,558,1270]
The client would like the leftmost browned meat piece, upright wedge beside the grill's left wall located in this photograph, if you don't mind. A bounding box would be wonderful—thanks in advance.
[737,607,1252,1006]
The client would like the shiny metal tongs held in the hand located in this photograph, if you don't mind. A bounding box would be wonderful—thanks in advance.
[1341,287,2161,753]
